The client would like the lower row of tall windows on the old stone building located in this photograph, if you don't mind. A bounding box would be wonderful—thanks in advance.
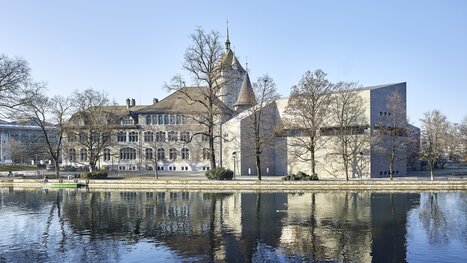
[68,147,210,162]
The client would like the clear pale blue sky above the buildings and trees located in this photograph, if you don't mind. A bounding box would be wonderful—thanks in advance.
[0,0,467,124]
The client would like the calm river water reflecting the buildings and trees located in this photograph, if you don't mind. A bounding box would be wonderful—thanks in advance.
[0,189,467,262]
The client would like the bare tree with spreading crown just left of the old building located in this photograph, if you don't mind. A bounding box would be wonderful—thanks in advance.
[17,94,71,178]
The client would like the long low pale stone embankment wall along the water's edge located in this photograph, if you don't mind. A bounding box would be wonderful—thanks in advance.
[0,179,467,191]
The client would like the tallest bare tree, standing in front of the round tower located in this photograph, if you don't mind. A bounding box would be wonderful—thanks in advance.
[166,28,234,168]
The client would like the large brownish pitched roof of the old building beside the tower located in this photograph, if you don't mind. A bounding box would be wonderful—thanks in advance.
[137,87,231,114]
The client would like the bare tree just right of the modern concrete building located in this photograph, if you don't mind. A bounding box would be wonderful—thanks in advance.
[420,110,448,180]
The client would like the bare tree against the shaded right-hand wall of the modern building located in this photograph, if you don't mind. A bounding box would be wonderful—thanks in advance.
[372,90,414,180]
